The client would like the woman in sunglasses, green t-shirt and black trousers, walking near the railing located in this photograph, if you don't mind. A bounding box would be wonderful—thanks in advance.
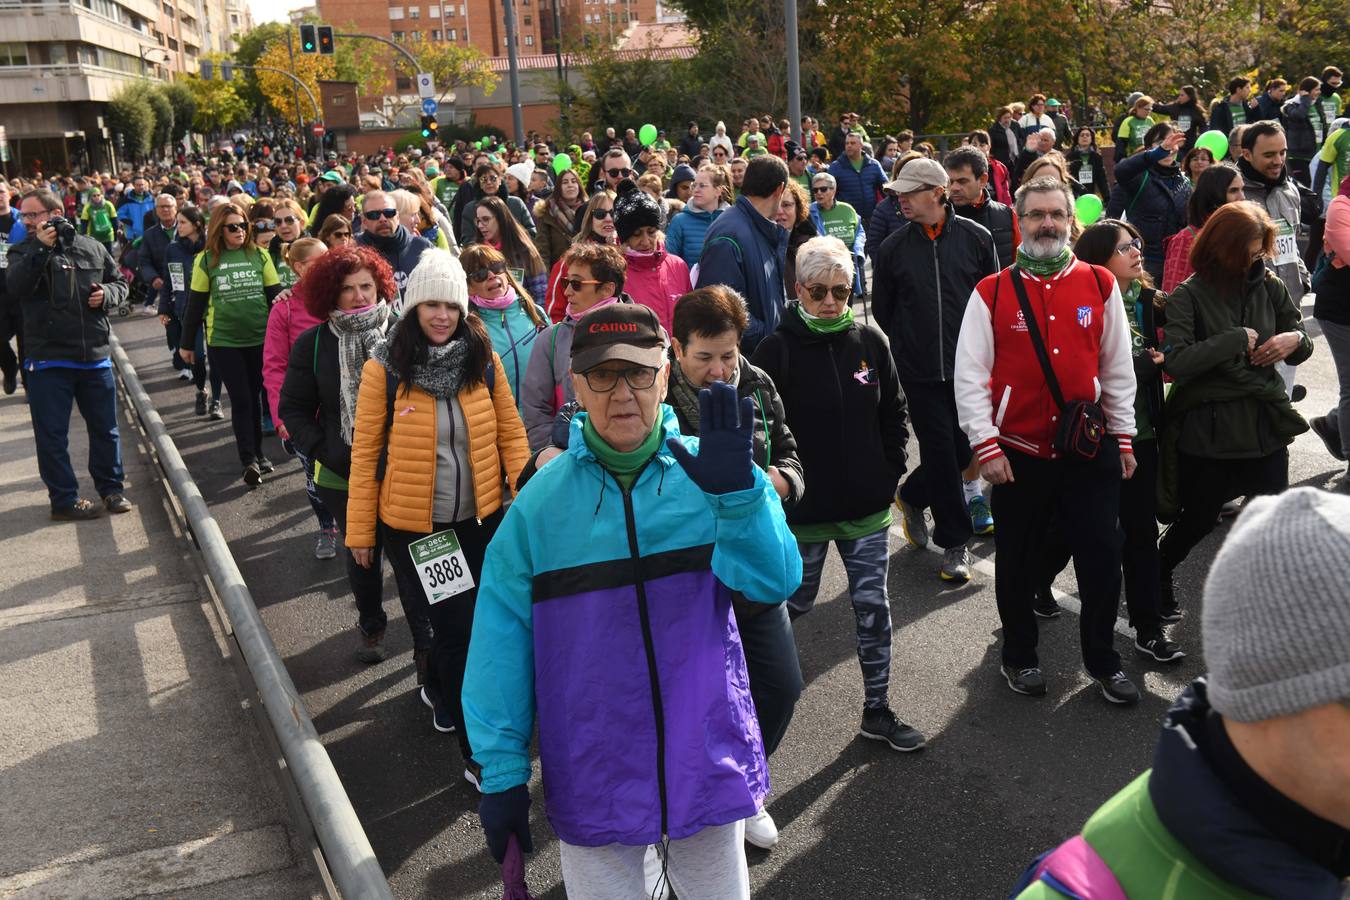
[178,205,281,486]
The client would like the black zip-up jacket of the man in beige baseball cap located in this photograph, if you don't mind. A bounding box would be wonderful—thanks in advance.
[872,201,999,382]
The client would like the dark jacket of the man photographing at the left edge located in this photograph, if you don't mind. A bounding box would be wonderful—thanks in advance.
[4,232,130,363]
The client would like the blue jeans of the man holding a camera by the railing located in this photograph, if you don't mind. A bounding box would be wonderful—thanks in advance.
[28,368,122,510]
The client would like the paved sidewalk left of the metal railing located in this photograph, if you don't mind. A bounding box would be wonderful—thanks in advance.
[0,389,321,900]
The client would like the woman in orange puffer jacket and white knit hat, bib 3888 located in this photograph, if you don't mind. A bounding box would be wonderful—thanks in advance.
[348,248,529,761]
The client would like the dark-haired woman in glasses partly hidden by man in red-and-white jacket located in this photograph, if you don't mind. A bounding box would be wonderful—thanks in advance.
[1037,219,1185,663]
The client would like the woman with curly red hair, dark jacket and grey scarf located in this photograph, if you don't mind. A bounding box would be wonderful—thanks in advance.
[278,246,421,673]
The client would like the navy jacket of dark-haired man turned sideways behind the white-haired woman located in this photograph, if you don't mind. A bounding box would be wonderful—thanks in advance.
[697,195,788,354]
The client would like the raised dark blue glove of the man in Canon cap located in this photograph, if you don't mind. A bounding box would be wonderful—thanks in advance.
[666,382,755,494]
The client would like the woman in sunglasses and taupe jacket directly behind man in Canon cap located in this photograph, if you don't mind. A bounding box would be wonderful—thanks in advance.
[520,241,633,451]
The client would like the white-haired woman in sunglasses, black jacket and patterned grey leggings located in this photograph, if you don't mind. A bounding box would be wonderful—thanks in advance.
[751,237,925,752]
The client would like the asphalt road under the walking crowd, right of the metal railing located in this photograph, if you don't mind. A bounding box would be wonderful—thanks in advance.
[116,302,1347,900]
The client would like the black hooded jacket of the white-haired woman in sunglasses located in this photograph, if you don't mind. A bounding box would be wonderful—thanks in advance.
[751,304,909,525]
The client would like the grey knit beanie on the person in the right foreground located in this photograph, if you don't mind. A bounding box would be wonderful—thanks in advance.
[1202,487,1350,722]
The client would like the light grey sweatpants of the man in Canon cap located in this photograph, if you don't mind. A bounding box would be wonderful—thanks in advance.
[559,822,751,900]
